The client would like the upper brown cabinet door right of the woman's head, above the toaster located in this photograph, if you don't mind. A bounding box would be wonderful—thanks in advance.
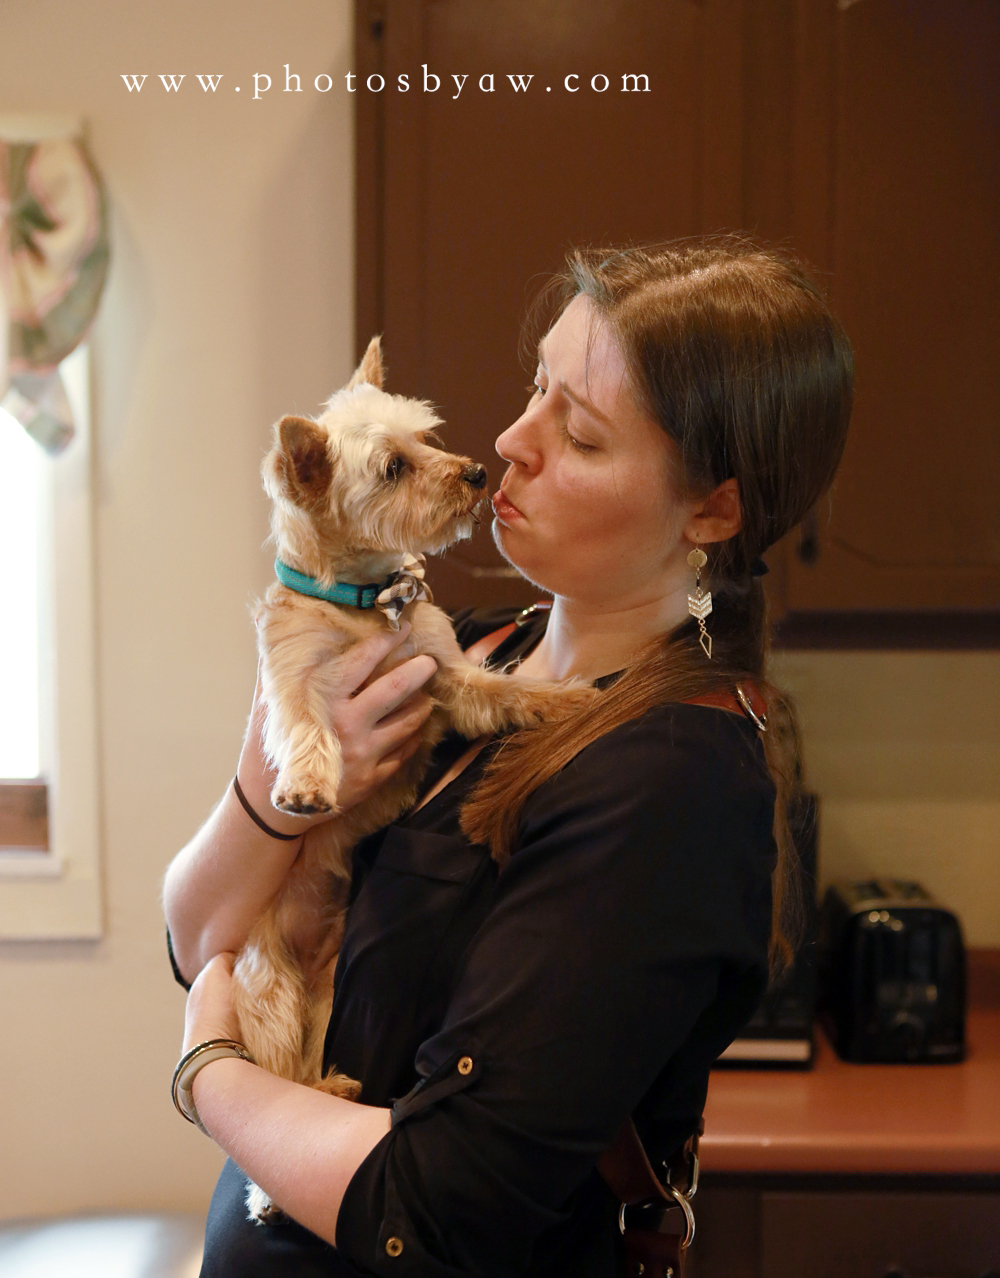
[785,0,1000,611]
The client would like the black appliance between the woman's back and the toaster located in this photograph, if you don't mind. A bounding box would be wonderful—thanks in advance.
[715,790,818,1070]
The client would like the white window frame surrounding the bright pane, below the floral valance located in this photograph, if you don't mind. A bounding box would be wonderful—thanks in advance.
[0,346,104,941]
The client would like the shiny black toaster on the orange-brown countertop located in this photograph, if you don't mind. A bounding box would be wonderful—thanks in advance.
[818,879,965,1065]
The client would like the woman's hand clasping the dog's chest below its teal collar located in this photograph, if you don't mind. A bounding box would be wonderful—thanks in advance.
[239,622,437,833]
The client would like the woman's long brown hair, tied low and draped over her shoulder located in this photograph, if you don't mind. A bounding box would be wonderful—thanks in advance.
[462,236,853,971]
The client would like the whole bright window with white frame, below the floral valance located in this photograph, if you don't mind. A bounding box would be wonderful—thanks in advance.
[0,348,101,939]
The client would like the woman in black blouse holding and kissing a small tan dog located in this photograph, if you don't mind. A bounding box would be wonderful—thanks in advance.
[165,240,852,1278]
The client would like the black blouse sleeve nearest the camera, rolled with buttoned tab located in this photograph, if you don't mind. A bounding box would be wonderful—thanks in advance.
[336,713,774,1278]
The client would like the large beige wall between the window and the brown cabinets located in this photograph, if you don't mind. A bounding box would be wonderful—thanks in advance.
[0,0,353,1217]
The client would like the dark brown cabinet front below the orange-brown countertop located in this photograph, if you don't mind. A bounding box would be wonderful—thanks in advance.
[761,1191,1000,1278]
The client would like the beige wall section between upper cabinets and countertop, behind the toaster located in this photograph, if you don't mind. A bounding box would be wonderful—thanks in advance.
[775,652,1000,946]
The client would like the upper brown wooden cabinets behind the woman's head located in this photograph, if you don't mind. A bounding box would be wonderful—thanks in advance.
[355,0,1000,642]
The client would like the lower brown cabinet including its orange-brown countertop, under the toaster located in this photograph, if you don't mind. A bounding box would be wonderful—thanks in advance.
[691,948,1000,1278]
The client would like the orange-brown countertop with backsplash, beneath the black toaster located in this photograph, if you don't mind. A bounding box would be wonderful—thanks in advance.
[701,950,1000,1176]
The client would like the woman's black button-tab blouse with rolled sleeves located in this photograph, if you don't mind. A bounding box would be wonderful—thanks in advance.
[191,612,775,1278]
